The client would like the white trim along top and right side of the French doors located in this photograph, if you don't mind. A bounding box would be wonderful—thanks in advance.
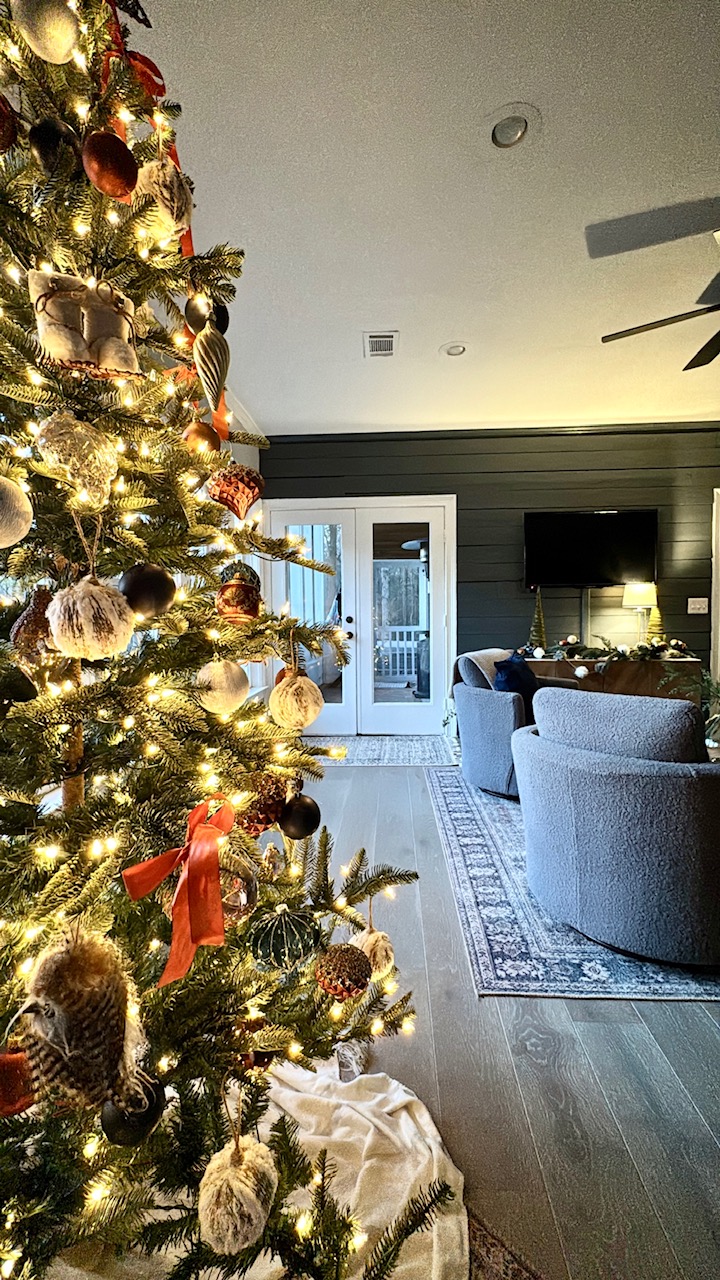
[263,493,457,737]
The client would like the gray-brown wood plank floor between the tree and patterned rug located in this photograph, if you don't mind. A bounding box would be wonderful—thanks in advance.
[313,765,720,1280]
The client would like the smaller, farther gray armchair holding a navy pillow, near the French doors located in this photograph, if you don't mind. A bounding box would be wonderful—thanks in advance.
[452,649,578,796]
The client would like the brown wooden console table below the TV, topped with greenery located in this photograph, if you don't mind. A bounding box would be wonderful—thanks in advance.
[528,658,702,707]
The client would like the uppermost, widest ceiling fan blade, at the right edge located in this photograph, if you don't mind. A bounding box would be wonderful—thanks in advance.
[585,196,720,257]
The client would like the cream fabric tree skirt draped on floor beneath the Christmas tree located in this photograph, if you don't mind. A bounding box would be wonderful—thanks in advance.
[50,1062,469,1280]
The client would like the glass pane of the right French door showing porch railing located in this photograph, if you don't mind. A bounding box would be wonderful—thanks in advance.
[373,522,430,703]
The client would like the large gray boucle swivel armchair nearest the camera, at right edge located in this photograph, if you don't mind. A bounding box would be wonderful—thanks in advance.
[512,690,720,965]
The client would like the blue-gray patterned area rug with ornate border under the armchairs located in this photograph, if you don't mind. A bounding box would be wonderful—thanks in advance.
[425,769,720,1000]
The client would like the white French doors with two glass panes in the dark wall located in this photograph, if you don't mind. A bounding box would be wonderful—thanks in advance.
[264,498,455,735]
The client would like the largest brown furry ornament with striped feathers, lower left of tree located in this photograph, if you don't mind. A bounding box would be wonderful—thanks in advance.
[20,928,142,1107]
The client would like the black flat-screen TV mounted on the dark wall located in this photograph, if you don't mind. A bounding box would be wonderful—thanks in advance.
[525,511,657,586]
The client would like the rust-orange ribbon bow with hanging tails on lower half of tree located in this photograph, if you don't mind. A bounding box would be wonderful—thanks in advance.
[123,792,234,987]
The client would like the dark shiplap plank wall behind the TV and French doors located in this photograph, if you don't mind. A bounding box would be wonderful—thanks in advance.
[261,422,720,663]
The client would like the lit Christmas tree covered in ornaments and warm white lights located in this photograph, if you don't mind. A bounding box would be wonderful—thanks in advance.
[0,0,450,1280]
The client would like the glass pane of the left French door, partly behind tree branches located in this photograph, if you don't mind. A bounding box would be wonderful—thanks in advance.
[286,525,345,703]
